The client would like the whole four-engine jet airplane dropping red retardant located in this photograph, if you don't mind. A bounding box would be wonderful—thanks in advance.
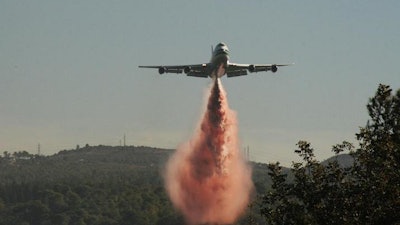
[139,42,292,78]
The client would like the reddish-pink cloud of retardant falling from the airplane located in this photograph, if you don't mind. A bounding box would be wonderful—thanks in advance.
[165,78,253,225]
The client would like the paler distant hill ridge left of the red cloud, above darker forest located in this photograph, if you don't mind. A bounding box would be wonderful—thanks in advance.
[0,145,172,184]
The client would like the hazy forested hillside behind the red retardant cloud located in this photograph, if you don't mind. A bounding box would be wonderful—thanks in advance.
[0,146,270,225]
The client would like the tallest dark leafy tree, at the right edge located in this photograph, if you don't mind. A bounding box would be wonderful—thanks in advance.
[352,85,400,224]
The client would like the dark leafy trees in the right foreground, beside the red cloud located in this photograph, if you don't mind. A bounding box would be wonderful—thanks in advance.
[260,85,400,224]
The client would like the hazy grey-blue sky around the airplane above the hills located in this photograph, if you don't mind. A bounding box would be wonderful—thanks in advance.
[0,0,400,165]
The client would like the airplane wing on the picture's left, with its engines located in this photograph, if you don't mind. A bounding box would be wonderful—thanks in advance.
[139,63,211,77]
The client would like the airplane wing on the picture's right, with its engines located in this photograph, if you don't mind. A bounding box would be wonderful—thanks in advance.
[226,63,292,77]
